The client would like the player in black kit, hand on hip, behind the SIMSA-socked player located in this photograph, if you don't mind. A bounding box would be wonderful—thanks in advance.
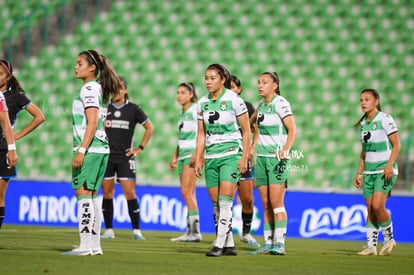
[101,77,154,240]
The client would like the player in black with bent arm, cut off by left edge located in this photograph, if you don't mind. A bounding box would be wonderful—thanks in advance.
[0,60,45,231]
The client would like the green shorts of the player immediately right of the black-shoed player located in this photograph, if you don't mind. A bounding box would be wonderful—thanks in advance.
[256,157,291,187]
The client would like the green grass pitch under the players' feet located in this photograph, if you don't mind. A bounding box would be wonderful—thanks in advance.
[0,224,414,275]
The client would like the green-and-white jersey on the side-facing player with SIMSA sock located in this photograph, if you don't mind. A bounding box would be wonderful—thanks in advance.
[72,81,109,154]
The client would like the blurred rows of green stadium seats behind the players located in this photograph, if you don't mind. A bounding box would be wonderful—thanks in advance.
[7,0,414,189]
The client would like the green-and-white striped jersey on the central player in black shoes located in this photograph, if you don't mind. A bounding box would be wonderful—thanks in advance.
[197,89,247,159]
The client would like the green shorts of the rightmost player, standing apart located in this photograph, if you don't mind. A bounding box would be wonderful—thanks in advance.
[362,174,398,198]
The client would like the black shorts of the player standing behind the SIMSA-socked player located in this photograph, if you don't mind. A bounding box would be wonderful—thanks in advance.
[104,155,136,181]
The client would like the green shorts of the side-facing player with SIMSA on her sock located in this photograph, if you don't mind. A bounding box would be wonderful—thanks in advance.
[72,153,109,191]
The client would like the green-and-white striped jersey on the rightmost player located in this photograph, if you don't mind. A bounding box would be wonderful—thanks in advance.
[360,112,398,175]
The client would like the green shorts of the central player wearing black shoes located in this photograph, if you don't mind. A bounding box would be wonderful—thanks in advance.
[204,152,241,188]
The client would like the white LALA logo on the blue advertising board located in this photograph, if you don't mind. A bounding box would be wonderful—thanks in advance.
[299,204,367,238]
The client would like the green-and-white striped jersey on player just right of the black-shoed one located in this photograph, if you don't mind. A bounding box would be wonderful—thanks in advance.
[256,95,293,158]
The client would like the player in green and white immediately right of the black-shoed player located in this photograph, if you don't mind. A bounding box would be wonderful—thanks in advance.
[249,72,296,255]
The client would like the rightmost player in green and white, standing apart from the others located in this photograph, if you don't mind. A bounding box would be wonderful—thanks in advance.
[354,89,401,255]
